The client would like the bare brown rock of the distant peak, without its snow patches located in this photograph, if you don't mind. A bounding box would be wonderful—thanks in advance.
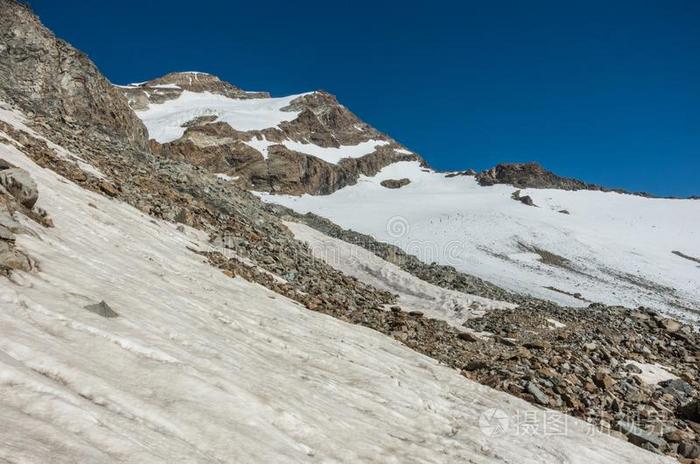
[127,73,420,194]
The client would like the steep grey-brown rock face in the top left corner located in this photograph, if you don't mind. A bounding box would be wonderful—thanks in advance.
[0,0,147,148]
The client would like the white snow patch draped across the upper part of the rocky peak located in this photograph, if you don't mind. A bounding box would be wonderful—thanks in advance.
[136,90,303,143]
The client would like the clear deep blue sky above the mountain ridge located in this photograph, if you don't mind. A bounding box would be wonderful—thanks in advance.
[31,0,700,196]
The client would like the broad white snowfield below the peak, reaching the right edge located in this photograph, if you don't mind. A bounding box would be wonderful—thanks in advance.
[262,162,700,320]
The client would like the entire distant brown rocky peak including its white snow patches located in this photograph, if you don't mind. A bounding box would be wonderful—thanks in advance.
[119,72,420,194]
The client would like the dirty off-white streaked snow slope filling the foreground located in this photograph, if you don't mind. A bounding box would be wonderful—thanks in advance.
[0,110,672,464]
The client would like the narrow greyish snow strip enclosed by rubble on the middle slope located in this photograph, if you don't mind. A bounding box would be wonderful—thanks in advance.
[285,222,516,330]
